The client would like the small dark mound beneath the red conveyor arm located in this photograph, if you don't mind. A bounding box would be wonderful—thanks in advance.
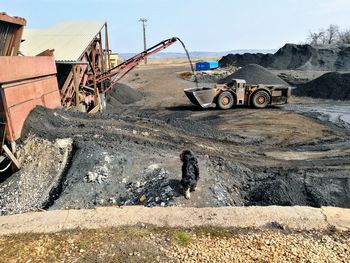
[107,83,143,107]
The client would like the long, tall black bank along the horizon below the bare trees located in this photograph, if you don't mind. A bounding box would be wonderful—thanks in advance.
[219,44,350,71]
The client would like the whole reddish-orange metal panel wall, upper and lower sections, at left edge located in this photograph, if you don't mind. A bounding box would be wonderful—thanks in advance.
[0,56,61,142]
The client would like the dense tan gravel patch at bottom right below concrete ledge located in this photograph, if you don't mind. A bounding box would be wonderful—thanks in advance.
[167,231,350,263]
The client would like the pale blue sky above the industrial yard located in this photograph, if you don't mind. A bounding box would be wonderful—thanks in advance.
[0,0,350,53]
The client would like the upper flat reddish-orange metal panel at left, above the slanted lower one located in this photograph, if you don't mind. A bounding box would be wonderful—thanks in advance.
[0,56,56,83]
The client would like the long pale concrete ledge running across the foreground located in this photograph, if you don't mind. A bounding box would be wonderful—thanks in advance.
[0,206,350,235]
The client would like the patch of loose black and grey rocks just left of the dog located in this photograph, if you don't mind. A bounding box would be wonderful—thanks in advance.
[119,168,179,207]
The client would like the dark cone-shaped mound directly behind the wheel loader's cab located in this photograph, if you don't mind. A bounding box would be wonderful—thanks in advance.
[218,64,289,86]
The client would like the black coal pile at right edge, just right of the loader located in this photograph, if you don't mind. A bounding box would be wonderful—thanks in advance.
[293,72,350,100]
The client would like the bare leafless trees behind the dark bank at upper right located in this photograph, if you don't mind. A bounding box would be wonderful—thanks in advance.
[307,25,350,45]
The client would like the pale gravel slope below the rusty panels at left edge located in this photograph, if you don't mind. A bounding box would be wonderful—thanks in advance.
[0,135,72,215]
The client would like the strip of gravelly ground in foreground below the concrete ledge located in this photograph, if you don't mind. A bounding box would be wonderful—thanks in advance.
[0,226,350,262]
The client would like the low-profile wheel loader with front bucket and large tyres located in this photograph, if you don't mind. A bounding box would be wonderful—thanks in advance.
[184,79,291,110]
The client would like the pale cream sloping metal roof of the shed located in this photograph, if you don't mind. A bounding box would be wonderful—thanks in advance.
[21,20,105,61]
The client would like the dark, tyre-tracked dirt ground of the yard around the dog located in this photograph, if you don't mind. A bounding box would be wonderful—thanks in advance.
[0,65,350,217]
